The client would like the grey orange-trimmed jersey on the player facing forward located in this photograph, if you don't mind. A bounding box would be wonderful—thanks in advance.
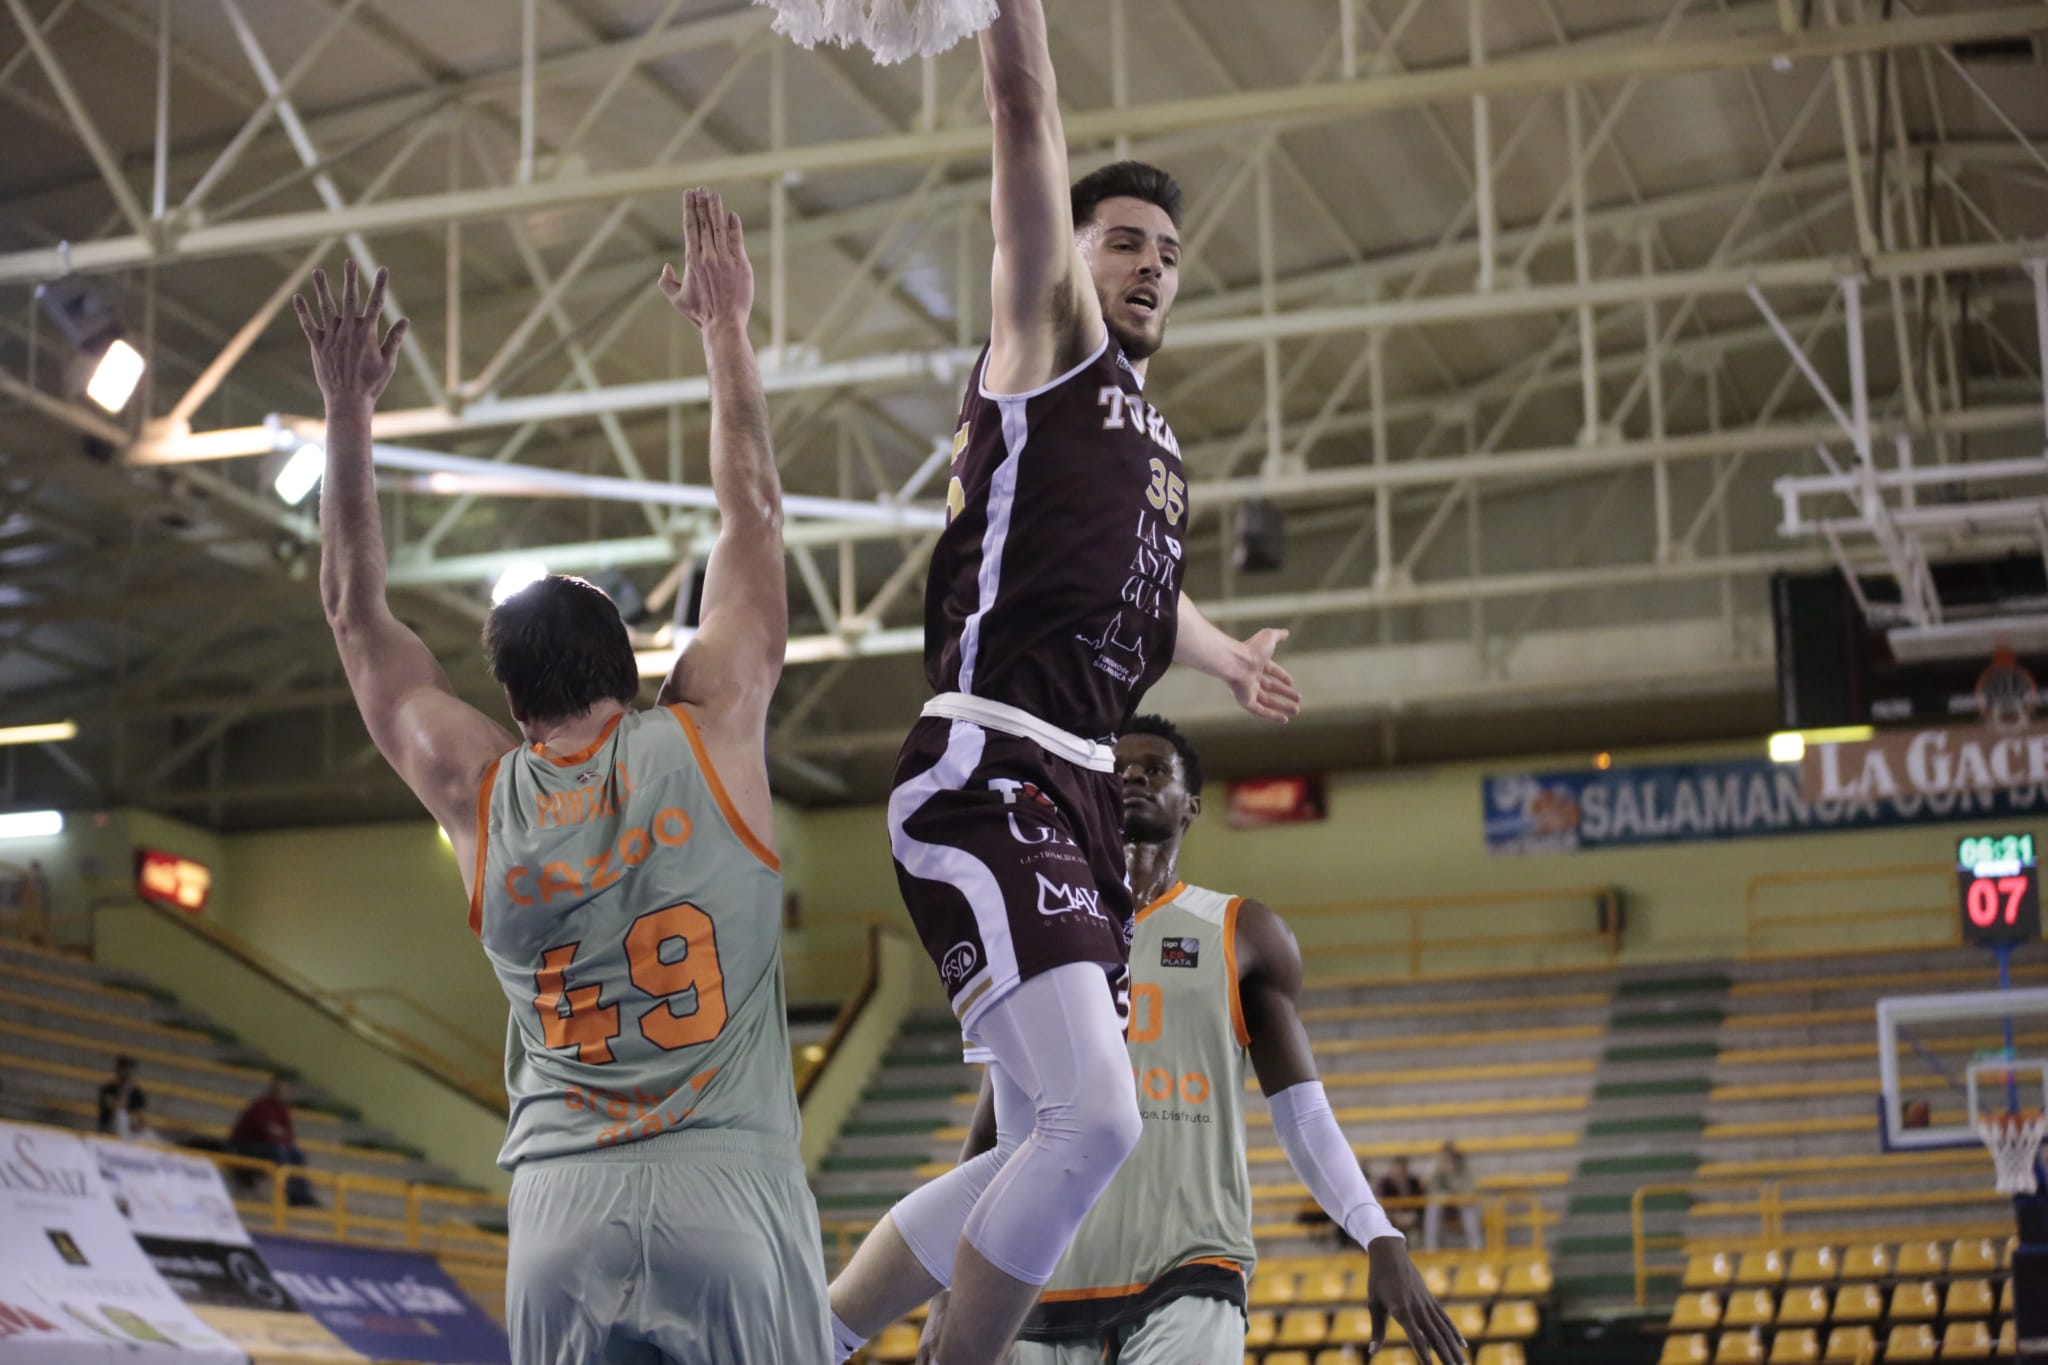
[1024,884,1255,1340]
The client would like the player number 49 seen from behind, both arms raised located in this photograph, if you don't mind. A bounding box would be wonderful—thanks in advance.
[297,190,829,1365]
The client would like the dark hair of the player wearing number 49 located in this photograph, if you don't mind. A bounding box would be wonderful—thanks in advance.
[483,573,639,722]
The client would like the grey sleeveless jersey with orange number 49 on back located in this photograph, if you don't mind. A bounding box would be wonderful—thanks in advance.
[471,706,797,1169]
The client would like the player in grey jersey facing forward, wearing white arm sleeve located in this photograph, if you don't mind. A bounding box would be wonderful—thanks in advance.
[926,716,1464,1365]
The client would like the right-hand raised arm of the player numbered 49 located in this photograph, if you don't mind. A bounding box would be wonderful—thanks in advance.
[659,190,788,747]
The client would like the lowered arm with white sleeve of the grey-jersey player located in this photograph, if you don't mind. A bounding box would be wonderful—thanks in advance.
[1237,900,1464,1365]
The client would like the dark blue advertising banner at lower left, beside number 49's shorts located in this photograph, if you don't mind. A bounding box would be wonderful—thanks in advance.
[254,1232,510,1365]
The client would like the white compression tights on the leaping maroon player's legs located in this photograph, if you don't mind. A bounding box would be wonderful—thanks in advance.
[889,962,1141,1285]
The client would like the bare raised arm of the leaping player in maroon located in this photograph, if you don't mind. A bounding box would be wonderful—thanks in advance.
[981,0,1102,393]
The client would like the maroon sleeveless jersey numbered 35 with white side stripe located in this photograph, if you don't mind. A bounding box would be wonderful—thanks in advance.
[924,338,1188,739]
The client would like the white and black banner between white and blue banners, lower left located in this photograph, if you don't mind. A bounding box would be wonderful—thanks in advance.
[92,1140,362,1365]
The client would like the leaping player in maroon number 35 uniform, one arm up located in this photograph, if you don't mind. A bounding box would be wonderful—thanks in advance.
[831,0,1300,1365]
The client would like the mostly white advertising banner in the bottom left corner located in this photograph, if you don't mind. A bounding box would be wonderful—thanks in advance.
[0,1124,248,1365]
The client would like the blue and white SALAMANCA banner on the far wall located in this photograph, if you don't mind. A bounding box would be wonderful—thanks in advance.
[1481,759,2048,853]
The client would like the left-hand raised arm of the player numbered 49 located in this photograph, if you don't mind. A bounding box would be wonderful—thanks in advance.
[293,262,518,880]
